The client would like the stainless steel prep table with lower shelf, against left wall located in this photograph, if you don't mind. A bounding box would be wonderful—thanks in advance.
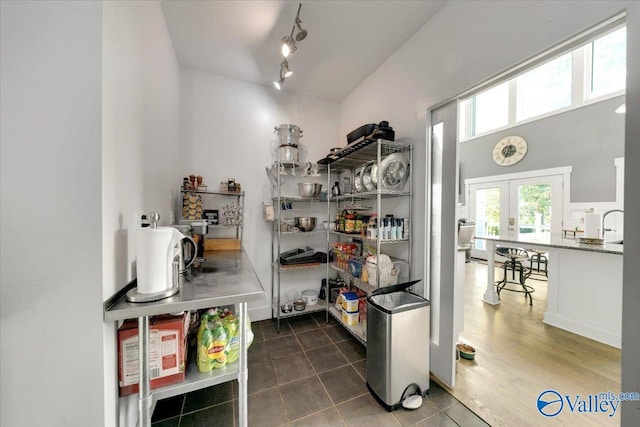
[104,250,266,427]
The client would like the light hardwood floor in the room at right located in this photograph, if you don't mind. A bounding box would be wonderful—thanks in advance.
[449,262,621,427]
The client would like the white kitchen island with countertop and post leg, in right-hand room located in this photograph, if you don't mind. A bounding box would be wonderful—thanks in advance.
[476,236,623,348]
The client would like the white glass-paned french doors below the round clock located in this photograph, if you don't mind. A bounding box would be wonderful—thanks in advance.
[468,175,564,259]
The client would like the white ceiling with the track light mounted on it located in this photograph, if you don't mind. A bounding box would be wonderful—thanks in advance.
[162,0,445,102]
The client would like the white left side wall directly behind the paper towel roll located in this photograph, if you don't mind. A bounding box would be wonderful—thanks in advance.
[102,1,181,425]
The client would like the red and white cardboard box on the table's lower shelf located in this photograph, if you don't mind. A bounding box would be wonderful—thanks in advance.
[118,312,190,396]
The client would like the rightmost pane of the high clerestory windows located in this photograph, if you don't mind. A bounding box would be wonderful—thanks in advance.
[590,27,627,97]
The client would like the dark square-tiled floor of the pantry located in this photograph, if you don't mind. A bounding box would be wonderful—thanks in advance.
[152,313,487,427]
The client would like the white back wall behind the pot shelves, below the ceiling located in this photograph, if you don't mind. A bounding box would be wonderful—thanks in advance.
[176,68,346,320]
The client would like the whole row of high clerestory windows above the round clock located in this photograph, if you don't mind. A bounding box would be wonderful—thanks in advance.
[458,26,627,141]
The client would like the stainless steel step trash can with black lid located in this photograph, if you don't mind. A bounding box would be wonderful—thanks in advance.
[367,280,430,411]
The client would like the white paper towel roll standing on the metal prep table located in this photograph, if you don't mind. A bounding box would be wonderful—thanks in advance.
[136,227,175,294]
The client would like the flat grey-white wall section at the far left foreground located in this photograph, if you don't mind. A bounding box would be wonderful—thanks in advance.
[0,1,104,426]
